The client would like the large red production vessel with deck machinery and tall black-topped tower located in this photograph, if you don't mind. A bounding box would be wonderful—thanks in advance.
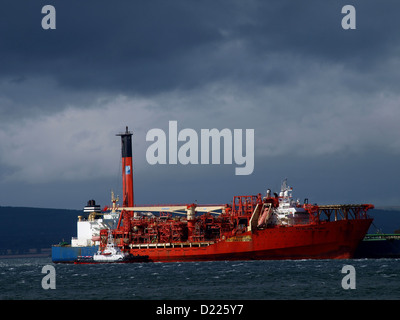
[100,128,374,262]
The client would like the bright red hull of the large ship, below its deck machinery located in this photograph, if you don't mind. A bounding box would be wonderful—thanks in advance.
[129,219,372,262]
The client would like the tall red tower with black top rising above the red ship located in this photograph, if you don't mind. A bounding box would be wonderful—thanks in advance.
[117,127,134,207]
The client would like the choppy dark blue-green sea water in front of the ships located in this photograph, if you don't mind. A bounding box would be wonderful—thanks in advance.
[0,258,400,301]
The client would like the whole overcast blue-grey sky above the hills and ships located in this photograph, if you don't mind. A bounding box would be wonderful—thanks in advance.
[0,0,400,209]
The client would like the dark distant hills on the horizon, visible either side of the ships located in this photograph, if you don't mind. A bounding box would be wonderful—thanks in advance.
[0,207,400,255]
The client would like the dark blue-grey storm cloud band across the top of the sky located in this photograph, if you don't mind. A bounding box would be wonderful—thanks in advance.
[0,0,400,99]
